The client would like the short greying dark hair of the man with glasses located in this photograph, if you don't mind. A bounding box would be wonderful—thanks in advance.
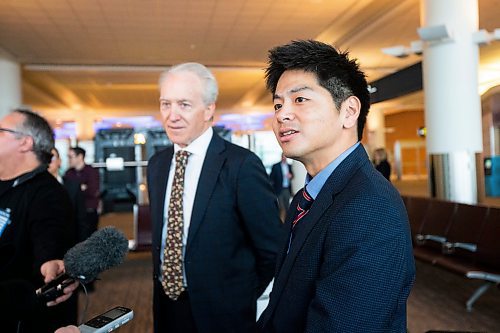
[14,109,54,164]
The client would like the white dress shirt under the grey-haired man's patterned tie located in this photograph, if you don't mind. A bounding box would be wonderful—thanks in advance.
[160,127,213,286]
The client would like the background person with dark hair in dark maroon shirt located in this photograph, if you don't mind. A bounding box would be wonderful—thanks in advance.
[64,147,100,241]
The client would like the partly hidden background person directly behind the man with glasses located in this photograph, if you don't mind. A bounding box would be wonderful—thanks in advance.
[47,148,88,242]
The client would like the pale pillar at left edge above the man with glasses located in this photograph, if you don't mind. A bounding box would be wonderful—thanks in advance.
[0,50,22,118]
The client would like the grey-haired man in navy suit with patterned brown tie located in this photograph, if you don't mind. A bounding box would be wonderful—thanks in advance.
[148,63,281,333]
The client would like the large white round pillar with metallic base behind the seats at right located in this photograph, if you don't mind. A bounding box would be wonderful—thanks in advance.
[420,0,483,203]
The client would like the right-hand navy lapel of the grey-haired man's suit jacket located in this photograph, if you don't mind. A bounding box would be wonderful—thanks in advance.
[186,132,226,252]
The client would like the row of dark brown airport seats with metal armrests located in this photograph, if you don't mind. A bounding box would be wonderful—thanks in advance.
[403,196,500,311]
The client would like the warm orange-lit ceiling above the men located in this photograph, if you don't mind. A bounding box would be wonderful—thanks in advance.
[0,0,500,127]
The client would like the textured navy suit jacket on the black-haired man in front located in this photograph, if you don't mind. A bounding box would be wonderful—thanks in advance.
[259,145,415,333]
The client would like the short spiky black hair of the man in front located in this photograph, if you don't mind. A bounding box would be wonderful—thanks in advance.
[266,40,370,140]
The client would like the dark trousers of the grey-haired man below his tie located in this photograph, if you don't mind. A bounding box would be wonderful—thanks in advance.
[153,281,197,333]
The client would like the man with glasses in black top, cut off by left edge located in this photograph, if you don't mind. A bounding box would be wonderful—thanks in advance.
[0,110,76,332]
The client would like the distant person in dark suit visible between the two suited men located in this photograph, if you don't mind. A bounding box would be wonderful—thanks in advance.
[269,153,293,221]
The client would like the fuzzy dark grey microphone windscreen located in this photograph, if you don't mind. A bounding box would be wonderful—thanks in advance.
[64,227,128,282]
